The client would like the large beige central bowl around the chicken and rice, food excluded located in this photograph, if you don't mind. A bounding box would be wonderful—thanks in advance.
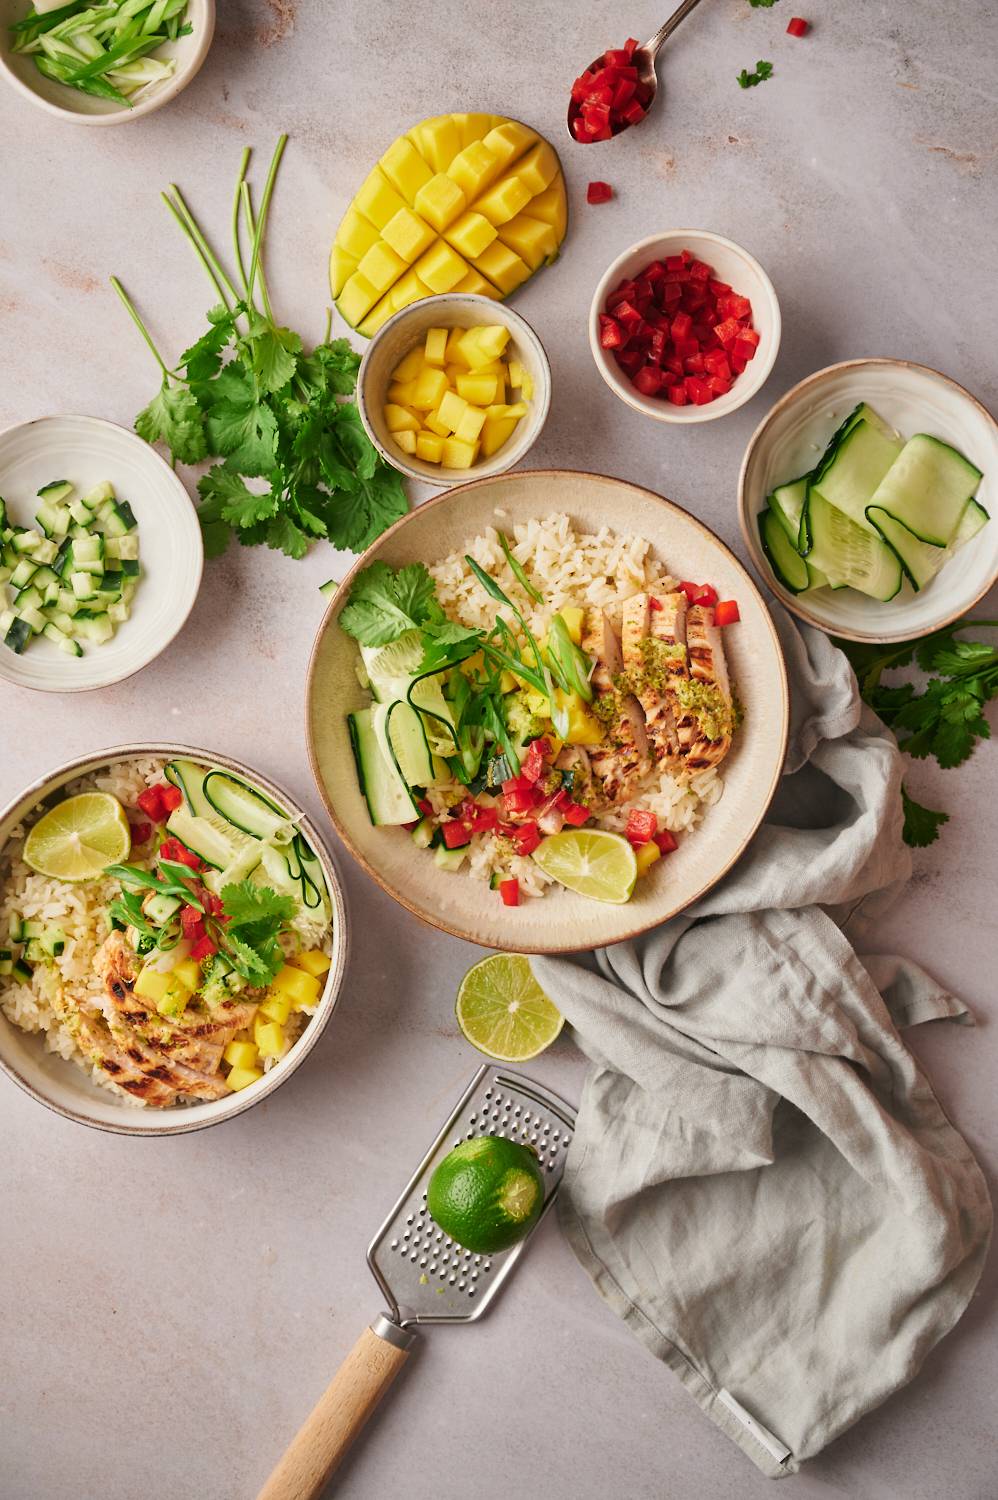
[306,470,788,953]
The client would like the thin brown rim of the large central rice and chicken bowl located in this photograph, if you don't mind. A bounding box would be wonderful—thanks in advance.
[305,468,789,954]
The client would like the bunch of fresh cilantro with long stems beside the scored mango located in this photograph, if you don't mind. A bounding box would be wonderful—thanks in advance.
[111,135,408,558]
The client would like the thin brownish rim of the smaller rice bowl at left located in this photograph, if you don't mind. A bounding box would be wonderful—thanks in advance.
[0,740,350,1136]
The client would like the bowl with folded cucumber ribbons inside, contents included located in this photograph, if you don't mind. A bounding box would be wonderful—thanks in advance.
[738,359,998,642]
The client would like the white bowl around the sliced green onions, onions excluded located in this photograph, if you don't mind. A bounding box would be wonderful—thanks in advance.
[0,0,215,125]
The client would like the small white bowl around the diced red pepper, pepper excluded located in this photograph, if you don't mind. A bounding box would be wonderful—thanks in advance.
[590,230,780,426]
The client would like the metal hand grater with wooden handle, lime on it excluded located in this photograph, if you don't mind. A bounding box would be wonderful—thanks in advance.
[258,1064,575,1500]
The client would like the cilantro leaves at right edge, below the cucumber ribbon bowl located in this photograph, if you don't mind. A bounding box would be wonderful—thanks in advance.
[837,620,998,848]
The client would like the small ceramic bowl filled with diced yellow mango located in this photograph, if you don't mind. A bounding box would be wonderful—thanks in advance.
[357,294,551,485]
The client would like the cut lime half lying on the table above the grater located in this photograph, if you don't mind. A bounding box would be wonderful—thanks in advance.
[455,953,564,1062]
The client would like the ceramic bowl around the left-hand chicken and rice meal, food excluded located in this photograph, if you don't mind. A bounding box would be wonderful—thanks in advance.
[0,744,347,1136]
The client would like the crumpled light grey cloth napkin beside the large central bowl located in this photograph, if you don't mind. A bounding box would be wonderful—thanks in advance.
[533,609,990,1478]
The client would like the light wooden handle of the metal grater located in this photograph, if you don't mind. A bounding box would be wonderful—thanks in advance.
[258,1319,413,1500]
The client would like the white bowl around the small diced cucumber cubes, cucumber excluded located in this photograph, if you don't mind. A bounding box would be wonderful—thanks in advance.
[0,417,204,693]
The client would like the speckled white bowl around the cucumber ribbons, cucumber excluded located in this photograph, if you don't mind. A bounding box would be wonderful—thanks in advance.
[738,360,998,641]
